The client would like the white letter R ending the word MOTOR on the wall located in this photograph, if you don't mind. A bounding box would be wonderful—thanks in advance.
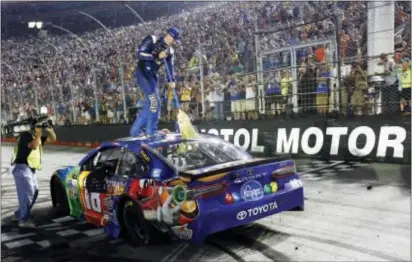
[376,126,406,158]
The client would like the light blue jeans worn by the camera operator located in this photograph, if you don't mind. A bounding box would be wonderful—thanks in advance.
[12,164,39,222]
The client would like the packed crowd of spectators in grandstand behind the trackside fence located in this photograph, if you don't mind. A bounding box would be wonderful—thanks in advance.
[1,1,411,125]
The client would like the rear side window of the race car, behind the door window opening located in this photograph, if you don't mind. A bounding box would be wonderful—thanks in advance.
[118,149,149,177]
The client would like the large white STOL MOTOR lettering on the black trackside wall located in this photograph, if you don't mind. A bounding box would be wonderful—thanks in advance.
[200,126,407,159]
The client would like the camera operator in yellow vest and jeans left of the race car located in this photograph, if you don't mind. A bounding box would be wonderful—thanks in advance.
[12,124,56,228]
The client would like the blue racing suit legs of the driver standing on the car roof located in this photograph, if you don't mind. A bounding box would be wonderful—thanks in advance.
[130,69,160,136]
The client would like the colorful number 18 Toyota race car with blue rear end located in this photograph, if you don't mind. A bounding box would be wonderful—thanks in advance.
[50,133,304,245]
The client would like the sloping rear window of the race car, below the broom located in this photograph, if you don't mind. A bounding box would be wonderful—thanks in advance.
[155,138,251,172]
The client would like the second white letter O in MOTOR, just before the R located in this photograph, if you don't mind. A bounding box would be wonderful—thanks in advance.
[348,126,376,157]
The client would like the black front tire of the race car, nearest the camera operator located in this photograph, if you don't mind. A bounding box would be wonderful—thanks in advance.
[51,178,70,218]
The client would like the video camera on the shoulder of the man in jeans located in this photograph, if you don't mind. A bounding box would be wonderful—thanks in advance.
[1,115,54,137]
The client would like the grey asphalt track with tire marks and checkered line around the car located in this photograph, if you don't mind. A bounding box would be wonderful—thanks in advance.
[1,144,411,262]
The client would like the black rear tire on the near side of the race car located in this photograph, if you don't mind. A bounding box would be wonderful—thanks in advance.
[122,200,153,246]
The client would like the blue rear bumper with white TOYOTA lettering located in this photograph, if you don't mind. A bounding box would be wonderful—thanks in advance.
[190,187,304,242]
